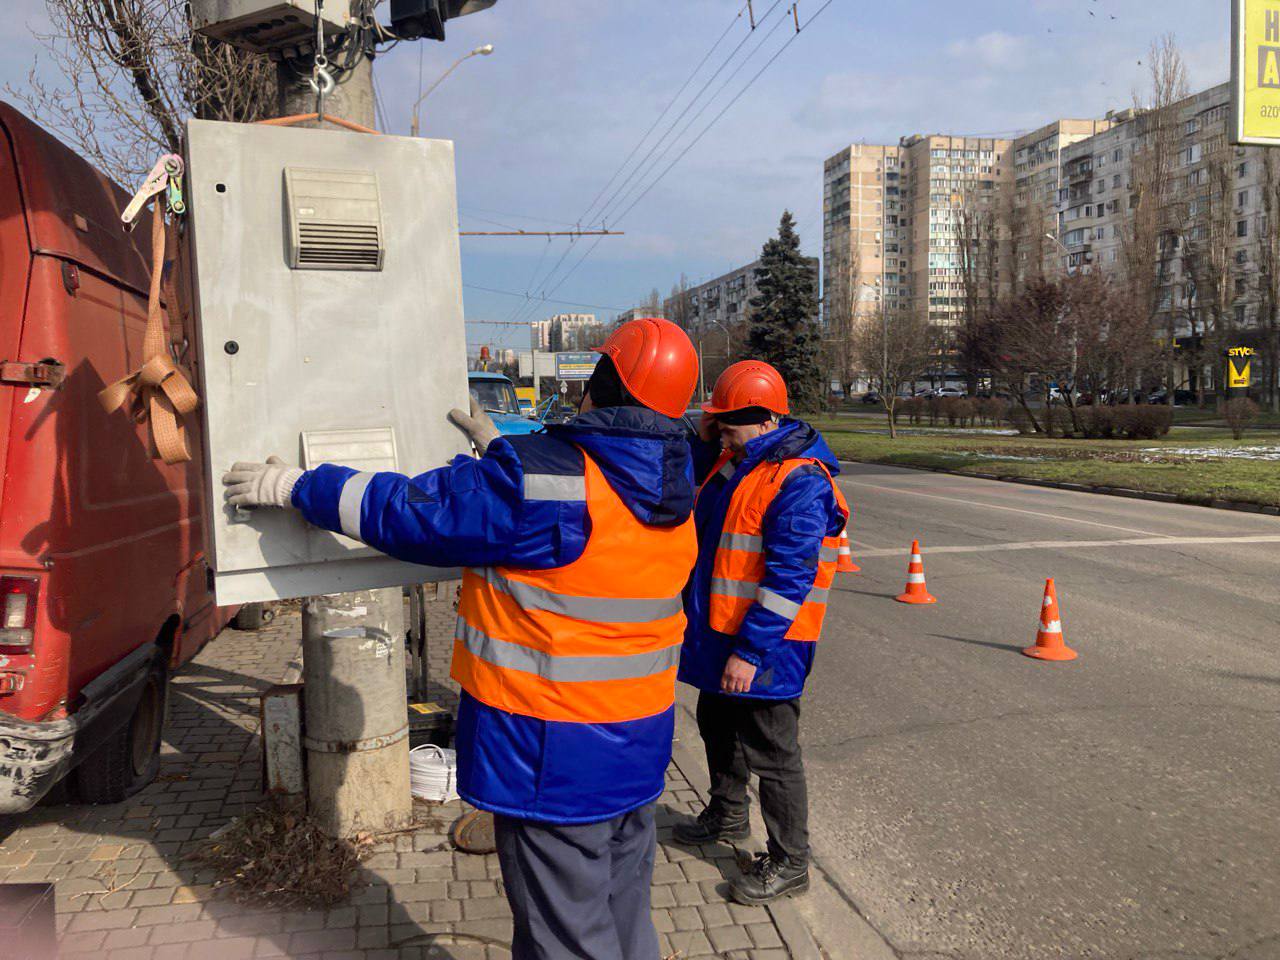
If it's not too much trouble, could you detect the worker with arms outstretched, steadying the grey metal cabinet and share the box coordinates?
[224,319,698,960]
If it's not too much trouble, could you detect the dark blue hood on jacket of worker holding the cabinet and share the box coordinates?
[547,407,696,526]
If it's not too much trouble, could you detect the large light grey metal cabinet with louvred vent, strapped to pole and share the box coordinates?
[187,120,470,605]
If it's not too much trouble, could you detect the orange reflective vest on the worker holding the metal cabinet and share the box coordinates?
[452,453,698,723]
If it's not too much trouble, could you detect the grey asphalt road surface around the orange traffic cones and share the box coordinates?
[797,465,1280,960]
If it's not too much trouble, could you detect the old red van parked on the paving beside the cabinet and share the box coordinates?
[0,104,254,813]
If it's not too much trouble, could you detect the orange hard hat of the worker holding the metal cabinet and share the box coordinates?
[595,316,698,417]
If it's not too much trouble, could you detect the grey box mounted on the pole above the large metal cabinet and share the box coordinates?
[191,0,351,54]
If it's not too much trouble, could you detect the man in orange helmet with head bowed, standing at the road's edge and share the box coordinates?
[675,360,849,904]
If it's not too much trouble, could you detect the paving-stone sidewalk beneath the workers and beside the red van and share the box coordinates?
[0,603,799,960]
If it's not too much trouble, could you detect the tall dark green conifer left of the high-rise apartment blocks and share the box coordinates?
[746,210,824,410]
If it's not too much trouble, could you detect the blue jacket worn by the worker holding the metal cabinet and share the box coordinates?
[293,407,694,823]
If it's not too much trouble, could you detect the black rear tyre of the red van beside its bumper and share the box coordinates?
[72,660,169,804]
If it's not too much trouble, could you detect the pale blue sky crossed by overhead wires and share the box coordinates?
[0,0,1229,344]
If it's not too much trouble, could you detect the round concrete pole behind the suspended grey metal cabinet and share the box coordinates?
[278,39,409,837]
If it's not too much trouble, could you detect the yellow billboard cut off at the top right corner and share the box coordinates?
[1231,0,1280,147]
